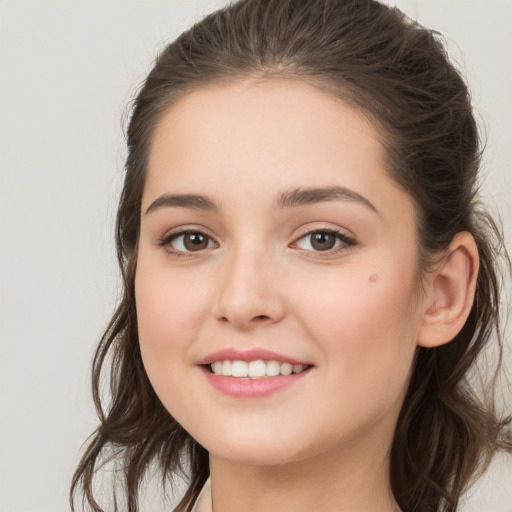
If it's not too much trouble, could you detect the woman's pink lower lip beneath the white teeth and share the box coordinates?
[202,367,311,398]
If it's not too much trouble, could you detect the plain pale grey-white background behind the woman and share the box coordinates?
[0,0,512,512]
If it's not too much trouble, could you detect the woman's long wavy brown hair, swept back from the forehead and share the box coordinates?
[70,0,510,512]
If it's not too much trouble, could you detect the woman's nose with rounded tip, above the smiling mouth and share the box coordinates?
[214,253,285,330]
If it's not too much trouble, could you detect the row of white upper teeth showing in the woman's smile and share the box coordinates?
[210,359,307,379]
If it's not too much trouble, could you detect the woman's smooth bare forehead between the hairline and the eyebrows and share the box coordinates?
[143,79,412,220]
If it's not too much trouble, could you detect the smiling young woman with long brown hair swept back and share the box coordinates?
[71,0,511,512]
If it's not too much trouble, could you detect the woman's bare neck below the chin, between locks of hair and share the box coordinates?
[210,440,399,512]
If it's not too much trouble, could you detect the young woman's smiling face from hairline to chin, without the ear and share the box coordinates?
[136,80,421,464]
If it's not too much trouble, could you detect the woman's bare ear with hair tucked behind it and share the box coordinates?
[417,231,479,348]
